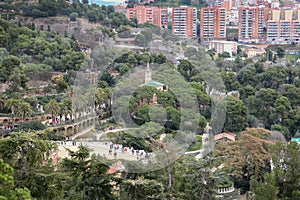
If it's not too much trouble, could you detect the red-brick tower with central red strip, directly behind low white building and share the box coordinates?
[200,6,226,41]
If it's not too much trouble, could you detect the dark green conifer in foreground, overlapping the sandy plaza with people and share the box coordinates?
[61,146,117,200]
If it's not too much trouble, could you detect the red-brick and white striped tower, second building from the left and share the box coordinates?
[172,6,197,37]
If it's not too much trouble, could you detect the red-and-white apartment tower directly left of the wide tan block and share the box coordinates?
[238,6,269,43]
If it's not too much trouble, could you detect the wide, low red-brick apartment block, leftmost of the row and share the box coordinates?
[126,6,168,28]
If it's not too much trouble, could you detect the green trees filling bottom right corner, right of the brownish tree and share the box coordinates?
[250,142,300,200]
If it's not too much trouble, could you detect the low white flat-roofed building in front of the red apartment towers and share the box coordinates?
[208,40,237,56]
